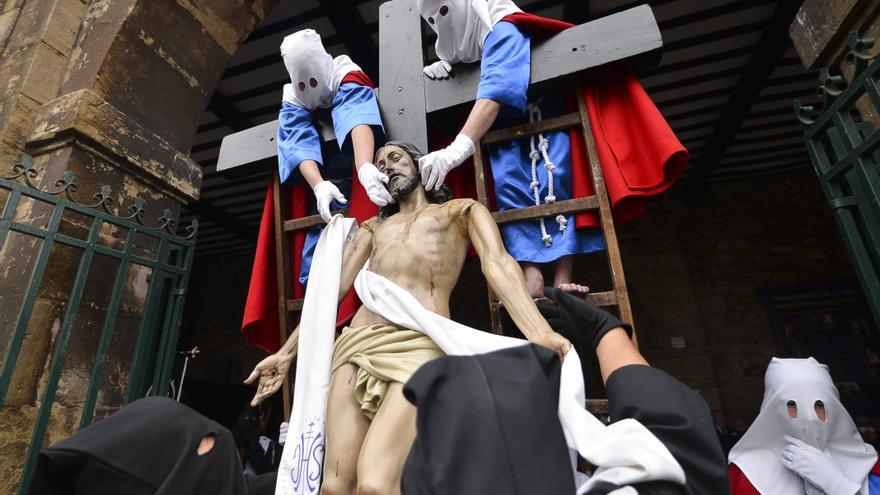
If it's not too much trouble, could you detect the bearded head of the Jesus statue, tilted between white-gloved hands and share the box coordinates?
[375,141,452,218]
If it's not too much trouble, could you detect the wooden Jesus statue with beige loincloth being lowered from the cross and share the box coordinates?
[246,142,571,494]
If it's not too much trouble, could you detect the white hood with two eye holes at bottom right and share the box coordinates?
[727,358,877,495]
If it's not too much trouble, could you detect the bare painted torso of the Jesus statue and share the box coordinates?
[351,199,473,327]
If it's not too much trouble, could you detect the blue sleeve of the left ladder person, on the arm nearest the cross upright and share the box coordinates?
[330,82,384,150]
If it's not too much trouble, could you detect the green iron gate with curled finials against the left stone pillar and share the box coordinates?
[0,157,198,493]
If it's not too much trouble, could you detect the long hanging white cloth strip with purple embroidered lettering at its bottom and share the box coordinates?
[275,215,357,495]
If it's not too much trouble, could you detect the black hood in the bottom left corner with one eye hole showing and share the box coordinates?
[29,397,274,495]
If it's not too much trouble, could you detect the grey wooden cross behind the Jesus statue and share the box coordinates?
[217,0,663,175]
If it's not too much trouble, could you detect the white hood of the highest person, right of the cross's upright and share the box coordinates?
[416,0,522,64]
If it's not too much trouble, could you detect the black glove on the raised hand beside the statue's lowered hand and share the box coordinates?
[536,287,632,349]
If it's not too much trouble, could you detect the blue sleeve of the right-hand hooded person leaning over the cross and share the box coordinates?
[477,21,532,113]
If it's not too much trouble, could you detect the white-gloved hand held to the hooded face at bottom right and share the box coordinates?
[781,435,862,495]
